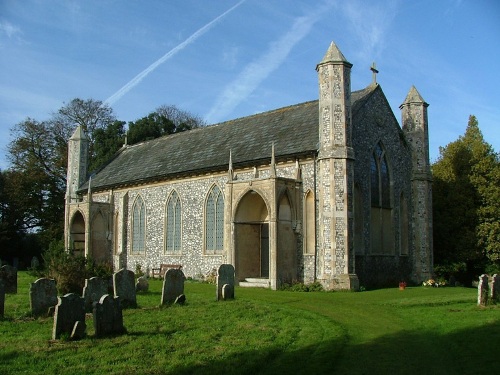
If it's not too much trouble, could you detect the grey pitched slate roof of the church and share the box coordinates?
[80,86,374,191]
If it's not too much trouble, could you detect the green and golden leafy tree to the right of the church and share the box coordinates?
[432,116,500,281]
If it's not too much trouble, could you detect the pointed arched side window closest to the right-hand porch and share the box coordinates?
[205,185,224,254]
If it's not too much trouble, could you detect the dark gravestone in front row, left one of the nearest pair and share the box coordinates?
[52,293,85,340]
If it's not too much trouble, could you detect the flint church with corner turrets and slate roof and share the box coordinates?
[65,42,433,290]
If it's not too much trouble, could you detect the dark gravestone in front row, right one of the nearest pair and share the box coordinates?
[93,294,125,336]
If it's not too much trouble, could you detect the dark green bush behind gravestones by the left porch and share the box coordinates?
[41,241,113,294]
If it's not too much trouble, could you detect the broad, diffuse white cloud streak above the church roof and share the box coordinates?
[205,2,332,124]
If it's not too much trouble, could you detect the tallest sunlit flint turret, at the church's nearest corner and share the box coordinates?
[316,42,359,289]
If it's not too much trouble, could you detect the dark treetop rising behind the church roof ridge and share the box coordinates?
[127,105,205,144]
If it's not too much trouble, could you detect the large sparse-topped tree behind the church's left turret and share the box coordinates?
[8,99,117,251]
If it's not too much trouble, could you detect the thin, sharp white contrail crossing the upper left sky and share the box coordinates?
[104,0,246,106]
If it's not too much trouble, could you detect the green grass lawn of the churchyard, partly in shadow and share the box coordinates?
[0,272,500,375]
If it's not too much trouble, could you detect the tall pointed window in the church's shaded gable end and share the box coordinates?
[370,142,394,254]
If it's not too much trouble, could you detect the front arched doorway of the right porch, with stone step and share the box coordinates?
[234,190,269,281]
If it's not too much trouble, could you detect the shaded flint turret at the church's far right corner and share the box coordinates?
[399,86,433,283]
